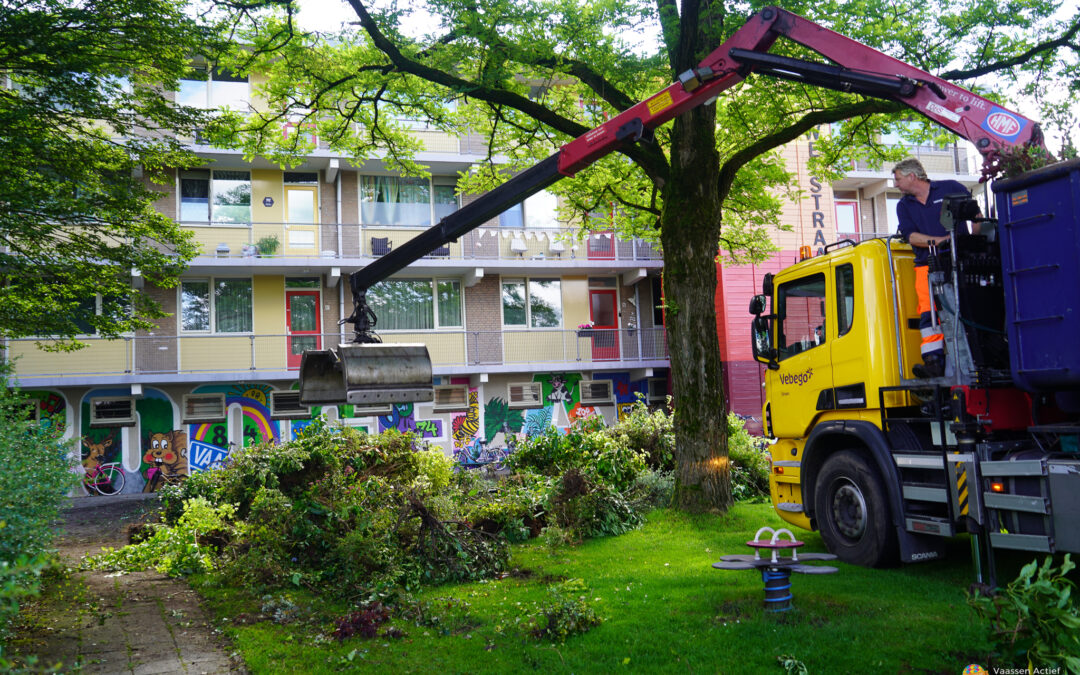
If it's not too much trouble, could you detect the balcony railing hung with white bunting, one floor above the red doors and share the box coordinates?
[181,222,663,264]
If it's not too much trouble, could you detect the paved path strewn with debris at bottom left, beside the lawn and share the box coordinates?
[16,495,246,675]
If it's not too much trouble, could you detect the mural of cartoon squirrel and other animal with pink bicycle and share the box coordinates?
[80,388,179,492]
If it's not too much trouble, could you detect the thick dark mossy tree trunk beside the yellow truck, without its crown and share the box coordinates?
[661,106,732,512]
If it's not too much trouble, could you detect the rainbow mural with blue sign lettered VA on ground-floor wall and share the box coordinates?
[188,383,281,471]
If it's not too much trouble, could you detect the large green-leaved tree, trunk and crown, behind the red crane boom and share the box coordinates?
[214,0,1078,510]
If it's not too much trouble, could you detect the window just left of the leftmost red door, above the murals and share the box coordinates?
[180,279,253,333]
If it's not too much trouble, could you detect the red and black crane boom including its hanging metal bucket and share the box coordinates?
[300,6,1041,405]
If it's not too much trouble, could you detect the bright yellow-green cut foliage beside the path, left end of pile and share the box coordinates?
[86,497,235,577]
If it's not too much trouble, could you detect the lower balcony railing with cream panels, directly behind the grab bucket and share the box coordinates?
[6,327,669,384]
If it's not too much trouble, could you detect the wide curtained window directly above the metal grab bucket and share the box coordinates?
[367,279,462,330]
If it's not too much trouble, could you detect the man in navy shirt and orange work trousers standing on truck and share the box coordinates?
[892,158,977,378]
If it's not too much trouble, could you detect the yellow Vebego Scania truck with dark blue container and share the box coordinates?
[751,160,1080,576]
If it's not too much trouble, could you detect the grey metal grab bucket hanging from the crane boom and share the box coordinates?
[300,343,435,405]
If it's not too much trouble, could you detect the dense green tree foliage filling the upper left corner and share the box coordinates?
[0,0,220,347]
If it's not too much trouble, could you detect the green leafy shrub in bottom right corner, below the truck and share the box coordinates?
[968,554,1080,673]
